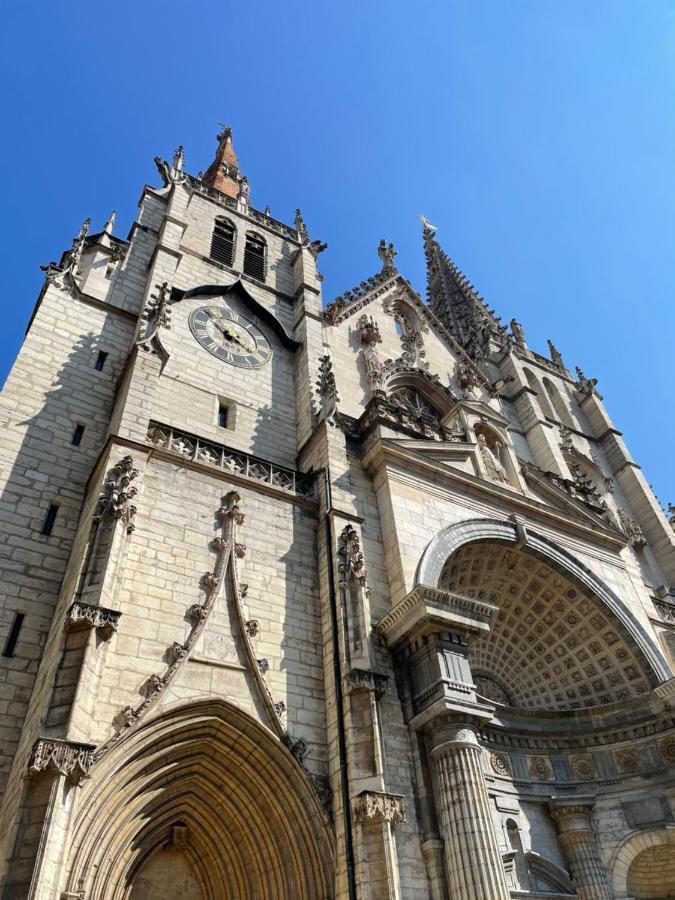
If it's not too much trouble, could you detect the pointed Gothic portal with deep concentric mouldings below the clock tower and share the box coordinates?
[68,700,334,900]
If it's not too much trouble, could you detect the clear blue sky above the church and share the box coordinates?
[0,0,675,502]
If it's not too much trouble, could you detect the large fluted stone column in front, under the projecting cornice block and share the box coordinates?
[429,715,509,900]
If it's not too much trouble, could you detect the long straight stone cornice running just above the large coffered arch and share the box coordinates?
[363,438,625,553]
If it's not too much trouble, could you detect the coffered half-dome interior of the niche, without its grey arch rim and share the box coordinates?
[439,541,653,710]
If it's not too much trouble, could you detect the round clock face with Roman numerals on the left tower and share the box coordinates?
[189,304,272,369]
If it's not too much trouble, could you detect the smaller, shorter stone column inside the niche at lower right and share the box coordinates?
[550,797,614,900]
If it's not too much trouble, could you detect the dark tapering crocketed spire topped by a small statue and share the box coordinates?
[420,216,505,359]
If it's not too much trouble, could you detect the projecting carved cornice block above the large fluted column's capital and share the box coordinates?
[377,584,497,647]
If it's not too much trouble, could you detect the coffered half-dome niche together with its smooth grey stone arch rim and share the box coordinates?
[416,519,670,710]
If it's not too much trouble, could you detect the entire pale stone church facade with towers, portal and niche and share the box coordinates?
[0,128,675,900]
